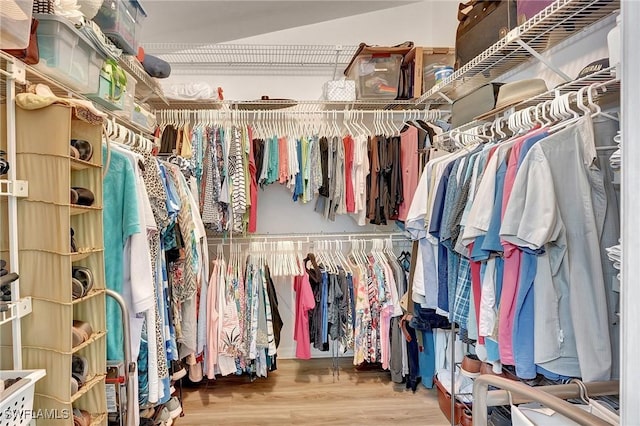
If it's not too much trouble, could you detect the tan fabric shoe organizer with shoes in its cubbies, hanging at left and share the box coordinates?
[10,105,107,426]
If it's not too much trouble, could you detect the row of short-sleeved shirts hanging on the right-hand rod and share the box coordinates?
[407,111,615,380]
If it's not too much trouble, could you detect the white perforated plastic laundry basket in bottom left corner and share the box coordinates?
[0,370,47,426]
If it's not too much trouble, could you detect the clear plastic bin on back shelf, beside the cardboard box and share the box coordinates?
[349,54,403,99]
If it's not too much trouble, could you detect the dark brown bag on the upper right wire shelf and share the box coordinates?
[455,0,518,69]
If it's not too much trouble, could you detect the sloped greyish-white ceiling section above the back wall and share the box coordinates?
[140,0,416,44]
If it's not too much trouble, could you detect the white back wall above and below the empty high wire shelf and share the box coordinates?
[166,0,458,100]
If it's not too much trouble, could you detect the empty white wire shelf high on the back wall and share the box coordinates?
[144,43,358,75]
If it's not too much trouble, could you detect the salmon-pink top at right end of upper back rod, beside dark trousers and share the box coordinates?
[398,126,420,221]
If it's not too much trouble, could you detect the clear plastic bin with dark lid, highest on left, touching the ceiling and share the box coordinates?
[93,0,147,55]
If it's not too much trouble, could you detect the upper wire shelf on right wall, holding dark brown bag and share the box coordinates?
[417,0,620,104]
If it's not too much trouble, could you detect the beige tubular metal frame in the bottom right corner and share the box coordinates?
[472,375,620,426]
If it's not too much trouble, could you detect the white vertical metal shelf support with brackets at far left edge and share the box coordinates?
[0,51,31,370]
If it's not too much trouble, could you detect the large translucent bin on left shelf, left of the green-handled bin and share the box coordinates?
[35,14,105,93]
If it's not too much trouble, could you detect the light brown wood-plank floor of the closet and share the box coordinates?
[175,358,448,426]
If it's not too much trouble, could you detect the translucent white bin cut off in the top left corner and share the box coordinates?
[0,0,33,49]
